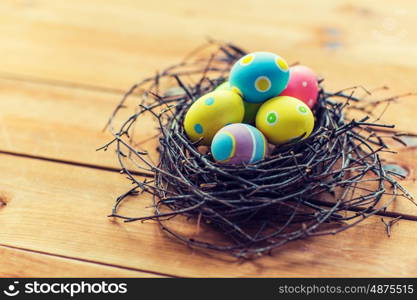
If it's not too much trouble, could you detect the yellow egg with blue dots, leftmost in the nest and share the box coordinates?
[184,91,244,145]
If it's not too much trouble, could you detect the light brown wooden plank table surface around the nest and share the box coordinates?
[0,0,417,277]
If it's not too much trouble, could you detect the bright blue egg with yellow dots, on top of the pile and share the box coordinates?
[229,52,290,103]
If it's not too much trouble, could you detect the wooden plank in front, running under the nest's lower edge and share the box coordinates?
[0,155,417,277]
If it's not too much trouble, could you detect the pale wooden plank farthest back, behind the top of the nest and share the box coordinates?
[0,0,417,95]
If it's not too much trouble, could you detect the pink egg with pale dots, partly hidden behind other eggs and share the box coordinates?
[280,66,319,108]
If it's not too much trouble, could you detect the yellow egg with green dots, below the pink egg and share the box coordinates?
[256,96,314,145]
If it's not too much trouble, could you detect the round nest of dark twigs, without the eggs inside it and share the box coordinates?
[101,42,413,258]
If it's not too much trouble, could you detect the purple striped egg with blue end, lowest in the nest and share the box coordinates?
[211,123,268,165]
